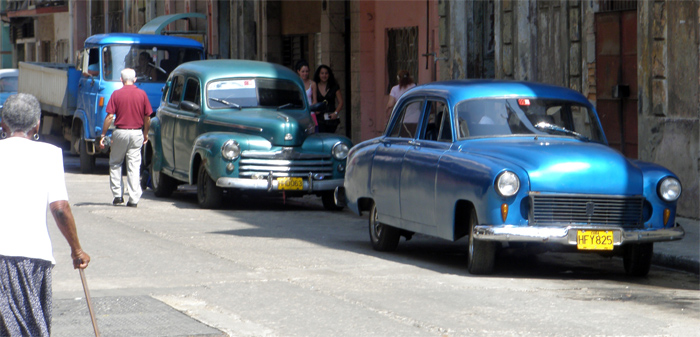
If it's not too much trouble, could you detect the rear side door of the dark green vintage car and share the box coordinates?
[158,75,185,172]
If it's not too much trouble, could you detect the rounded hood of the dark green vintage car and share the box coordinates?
[206,108,314,146]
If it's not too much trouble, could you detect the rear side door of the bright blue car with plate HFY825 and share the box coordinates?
[371,98,424,225]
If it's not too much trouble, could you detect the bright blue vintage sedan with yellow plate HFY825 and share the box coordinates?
[344,80,684,276]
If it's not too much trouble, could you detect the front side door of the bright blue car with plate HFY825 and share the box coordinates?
[400,98,452,234]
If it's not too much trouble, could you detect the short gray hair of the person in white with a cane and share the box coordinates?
[2,93,41,133]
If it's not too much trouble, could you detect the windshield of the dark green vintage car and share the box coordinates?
[207,78,304,109]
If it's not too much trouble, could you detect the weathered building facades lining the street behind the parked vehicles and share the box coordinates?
[0,0,700,218]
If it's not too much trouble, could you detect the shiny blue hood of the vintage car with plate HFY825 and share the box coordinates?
[461,137,644,195]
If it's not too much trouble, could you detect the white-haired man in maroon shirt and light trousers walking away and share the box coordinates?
[100,68,153,207]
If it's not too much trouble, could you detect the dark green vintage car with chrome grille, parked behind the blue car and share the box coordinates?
[150,60,352,210]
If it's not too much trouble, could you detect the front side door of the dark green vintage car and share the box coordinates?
[173,77,202,177]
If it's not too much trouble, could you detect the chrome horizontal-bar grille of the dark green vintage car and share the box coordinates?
[238,148,333,178]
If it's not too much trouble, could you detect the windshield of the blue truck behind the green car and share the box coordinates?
[102,45,202,83]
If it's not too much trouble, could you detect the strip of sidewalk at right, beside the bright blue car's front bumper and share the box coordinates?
[652,218,700,274]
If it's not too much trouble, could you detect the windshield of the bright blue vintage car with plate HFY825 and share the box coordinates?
[455,98,604,143]
